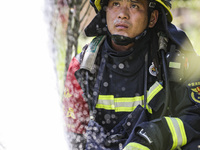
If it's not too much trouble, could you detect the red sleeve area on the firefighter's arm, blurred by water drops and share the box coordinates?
[63,57,89,147]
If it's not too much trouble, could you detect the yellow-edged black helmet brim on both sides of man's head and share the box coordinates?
[90,0,173,22]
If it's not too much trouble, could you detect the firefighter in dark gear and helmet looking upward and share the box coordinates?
[63,0,200,150]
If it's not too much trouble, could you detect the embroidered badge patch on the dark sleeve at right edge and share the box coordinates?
[188,82,200,103]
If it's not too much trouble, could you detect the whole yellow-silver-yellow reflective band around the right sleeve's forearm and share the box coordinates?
[165,117,187,150]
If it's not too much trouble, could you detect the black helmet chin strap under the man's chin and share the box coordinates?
[107,29,147,46]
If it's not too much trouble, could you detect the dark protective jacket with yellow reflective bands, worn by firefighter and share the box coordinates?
[63,22,200,150]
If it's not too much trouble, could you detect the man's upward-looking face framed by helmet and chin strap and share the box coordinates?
[106,0,148,38]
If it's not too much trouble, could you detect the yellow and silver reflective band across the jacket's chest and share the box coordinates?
[96,81,163,113]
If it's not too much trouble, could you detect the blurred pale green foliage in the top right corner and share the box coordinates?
[172,0,200,54]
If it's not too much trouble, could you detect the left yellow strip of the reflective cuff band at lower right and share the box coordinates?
[165,117,178,150]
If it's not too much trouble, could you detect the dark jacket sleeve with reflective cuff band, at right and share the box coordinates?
[129,53,200,150]
